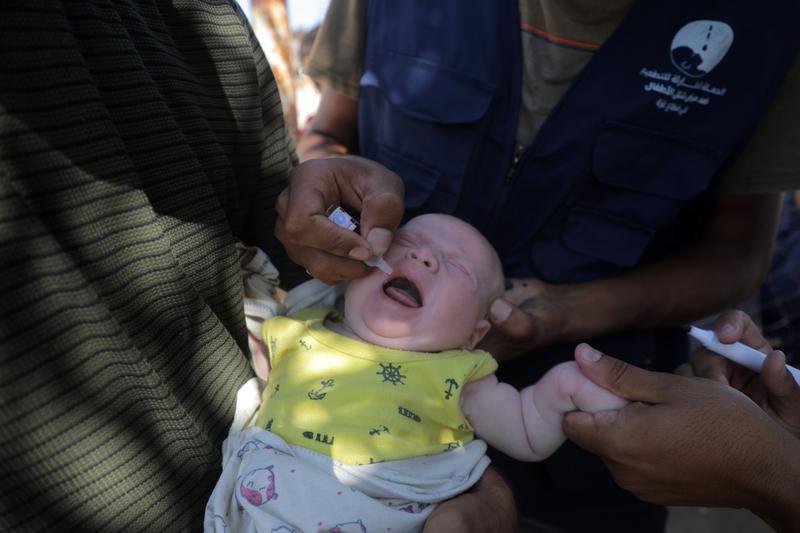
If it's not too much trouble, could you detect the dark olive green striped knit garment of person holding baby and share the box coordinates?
[0,0,304,531]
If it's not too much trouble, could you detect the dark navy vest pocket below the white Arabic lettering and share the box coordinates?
[562,122,720,268]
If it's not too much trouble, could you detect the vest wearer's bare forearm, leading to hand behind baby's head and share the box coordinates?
[553,194,780,341]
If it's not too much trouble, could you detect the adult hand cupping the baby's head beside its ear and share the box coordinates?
[478,278,567,361]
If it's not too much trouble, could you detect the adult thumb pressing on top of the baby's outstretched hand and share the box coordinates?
[575,343,676,403]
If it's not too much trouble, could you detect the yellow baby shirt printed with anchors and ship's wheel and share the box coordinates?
[256,309,497,464]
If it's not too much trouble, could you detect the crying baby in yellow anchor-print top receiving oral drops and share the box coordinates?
[206,215,626,533]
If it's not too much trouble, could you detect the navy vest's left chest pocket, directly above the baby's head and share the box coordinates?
[359,52,492,212]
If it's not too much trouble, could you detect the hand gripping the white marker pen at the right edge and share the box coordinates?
[692,311,800,437]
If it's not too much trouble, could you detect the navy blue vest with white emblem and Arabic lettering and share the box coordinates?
[359,0,800,370]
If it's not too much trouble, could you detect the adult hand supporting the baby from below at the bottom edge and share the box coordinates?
[423,467,517,533]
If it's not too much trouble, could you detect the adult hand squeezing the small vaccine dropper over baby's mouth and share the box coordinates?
[275,156,404,283]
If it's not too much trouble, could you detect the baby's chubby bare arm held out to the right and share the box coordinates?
[461,362,628,461]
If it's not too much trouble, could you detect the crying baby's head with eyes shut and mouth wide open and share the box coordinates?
[345,215,503,352]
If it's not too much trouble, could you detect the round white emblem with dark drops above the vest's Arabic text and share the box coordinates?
[670,20,733,78]
